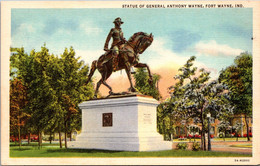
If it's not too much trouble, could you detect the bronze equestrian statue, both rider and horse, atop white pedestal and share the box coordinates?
[87,18,153,97]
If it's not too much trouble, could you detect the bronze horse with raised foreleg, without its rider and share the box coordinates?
[86,32,153,98]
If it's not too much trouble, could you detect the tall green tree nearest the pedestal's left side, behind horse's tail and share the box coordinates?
[58,47,94,148]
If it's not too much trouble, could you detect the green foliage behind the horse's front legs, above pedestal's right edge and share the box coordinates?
[134,68,161,100]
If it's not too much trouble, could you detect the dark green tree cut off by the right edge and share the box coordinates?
[219,52,253,141]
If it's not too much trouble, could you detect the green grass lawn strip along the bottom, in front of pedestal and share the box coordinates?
[10,144,252,157]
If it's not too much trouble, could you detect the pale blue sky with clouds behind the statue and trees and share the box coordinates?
[11,8,252,97]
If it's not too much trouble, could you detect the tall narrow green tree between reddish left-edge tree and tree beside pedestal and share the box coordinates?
[29,46,59,147]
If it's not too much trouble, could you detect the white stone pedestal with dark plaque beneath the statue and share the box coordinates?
[68,95,172,151]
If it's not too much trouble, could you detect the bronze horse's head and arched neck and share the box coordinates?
[129,32,153,54]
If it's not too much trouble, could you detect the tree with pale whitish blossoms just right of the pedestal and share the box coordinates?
[167,56,232,150]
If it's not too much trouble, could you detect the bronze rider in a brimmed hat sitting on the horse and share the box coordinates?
[103,17,126,71]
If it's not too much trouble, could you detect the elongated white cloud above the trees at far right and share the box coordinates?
[195,40,243,56]
